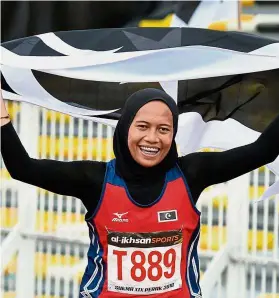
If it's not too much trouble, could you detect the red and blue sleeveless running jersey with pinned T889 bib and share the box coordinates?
[79,160,201,298]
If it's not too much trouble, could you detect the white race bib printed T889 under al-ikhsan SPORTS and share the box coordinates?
[107,231,182,295]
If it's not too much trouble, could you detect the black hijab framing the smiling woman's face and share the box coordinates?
[113,88,178,186]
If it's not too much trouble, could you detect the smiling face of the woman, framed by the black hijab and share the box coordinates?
[128,101,173,167]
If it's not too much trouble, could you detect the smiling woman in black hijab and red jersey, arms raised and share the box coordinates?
[1,89,279,298]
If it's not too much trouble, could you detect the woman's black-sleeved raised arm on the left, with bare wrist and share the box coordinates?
[0,87,105,201]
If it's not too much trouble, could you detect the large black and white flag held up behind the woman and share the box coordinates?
[1,27,279,199]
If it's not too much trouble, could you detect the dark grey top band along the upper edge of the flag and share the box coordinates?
[2,27,278,56]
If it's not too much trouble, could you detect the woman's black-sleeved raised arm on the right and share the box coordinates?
[179,115,279,201]
